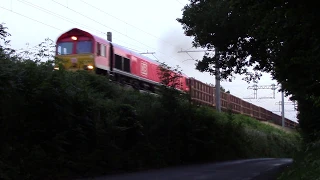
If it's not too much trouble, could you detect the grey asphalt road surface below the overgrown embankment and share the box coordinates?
[79,158,292,180]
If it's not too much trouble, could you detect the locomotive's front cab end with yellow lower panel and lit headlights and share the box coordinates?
[55,28,95,71]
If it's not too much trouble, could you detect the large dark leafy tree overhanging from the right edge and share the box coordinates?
[177,0,320,141]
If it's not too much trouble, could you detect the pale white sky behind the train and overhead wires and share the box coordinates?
[0,0,297,121]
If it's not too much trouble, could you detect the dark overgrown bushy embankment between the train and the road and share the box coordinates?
[0,24,299,180]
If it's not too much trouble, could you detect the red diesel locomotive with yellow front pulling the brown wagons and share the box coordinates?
[56,28,188,92]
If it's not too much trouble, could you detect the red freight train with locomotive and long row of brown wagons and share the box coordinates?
[55,28,298,128]
